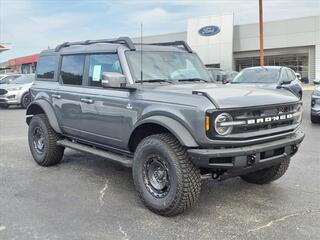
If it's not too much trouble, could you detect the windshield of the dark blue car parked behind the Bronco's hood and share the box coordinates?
[232,68,280,83]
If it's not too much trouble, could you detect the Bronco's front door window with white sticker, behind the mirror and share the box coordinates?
[89,53,122,87]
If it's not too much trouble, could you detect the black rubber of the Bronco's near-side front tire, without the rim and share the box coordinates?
[132,133,201,216]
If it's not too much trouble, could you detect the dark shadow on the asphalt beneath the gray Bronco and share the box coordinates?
[59,150,283,217]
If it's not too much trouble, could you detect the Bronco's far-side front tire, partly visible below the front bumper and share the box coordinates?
[241,159,290,184]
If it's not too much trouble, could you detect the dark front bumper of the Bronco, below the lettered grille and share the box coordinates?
[188,131,305,173]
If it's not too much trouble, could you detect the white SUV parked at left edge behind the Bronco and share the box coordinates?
[0,74,35,108]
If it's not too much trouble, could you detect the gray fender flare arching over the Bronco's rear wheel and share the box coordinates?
[26,99,62,133]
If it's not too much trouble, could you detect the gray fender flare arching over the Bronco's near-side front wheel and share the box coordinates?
[135,116,199,148]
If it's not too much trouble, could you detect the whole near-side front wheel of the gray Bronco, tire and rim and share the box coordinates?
[132,134,201,216]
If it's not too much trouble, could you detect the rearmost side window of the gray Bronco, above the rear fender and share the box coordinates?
[37,56,58,79]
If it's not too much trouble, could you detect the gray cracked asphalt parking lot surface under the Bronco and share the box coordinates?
[0,91,320,240]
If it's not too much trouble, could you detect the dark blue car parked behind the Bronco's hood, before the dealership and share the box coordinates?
[231,66,302,99]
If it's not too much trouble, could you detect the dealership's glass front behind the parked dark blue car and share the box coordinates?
[235,53,309,79]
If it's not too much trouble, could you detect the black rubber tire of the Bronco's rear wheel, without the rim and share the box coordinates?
[28,114,64,167]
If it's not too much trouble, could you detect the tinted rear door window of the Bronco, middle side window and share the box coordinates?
[60,55,85,85]
